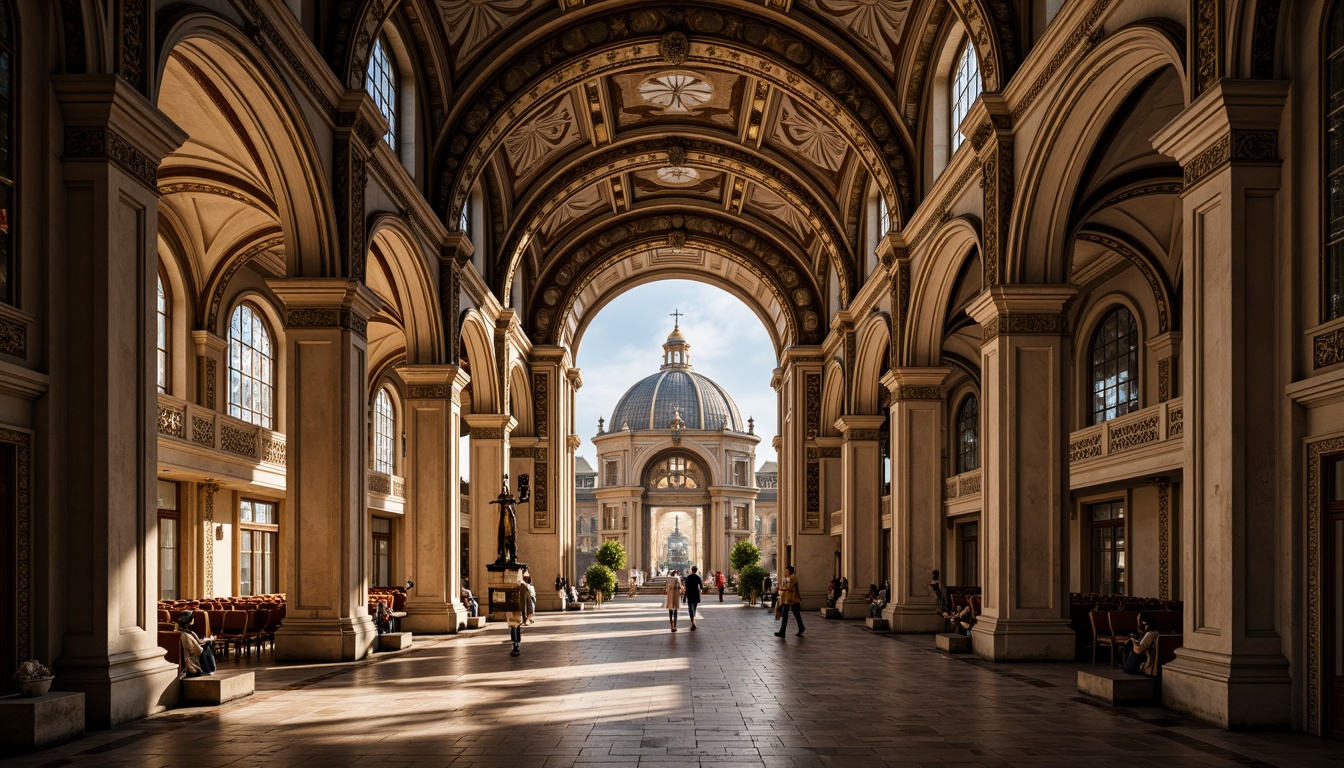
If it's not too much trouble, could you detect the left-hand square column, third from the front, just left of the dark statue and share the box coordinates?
[396,366,470,635]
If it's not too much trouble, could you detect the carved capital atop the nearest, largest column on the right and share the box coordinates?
[1152,78,1289,191]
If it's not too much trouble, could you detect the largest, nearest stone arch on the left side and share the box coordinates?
[153,11,341,277]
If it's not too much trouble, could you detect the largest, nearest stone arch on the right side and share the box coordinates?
[1003,22,1188,282]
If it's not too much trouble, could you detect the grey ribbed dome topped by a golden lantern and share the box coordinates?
[610,322,743,432]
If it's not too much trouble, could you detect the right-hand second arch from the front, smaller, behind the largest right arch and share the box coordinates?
[908,217,981,366]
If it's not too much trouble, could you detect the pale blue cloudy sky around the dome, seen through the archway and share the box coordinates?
[575,280,778,468]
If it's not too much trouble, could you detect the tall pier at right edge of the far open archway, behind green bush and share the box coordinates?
[770,346,835,611]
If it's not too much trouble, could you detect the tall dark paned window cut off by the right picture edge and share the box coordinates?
[1321,3,1344,320]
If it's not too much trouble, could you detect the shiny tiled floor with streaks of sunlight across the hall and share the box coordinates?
[5,597,1344,768]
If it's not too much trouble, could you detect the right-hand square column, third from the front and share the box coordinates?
[882,367,952,632]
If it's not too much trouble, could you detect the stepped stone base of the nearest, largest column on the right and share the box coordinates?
[1163,648,1293,729]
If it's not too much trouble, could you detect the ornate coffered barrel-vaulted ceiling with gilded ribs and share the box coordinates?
[336,0,1016,343]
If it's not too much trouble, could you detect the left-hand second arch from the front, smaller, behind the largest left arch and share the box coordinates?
[366,214,444,363]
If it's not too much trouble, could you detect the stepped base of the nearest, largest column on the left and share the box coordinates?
[55,646,177,729]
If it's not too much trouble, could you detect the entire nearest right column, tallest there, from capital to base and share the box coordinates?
[1153,78,1298,728]
